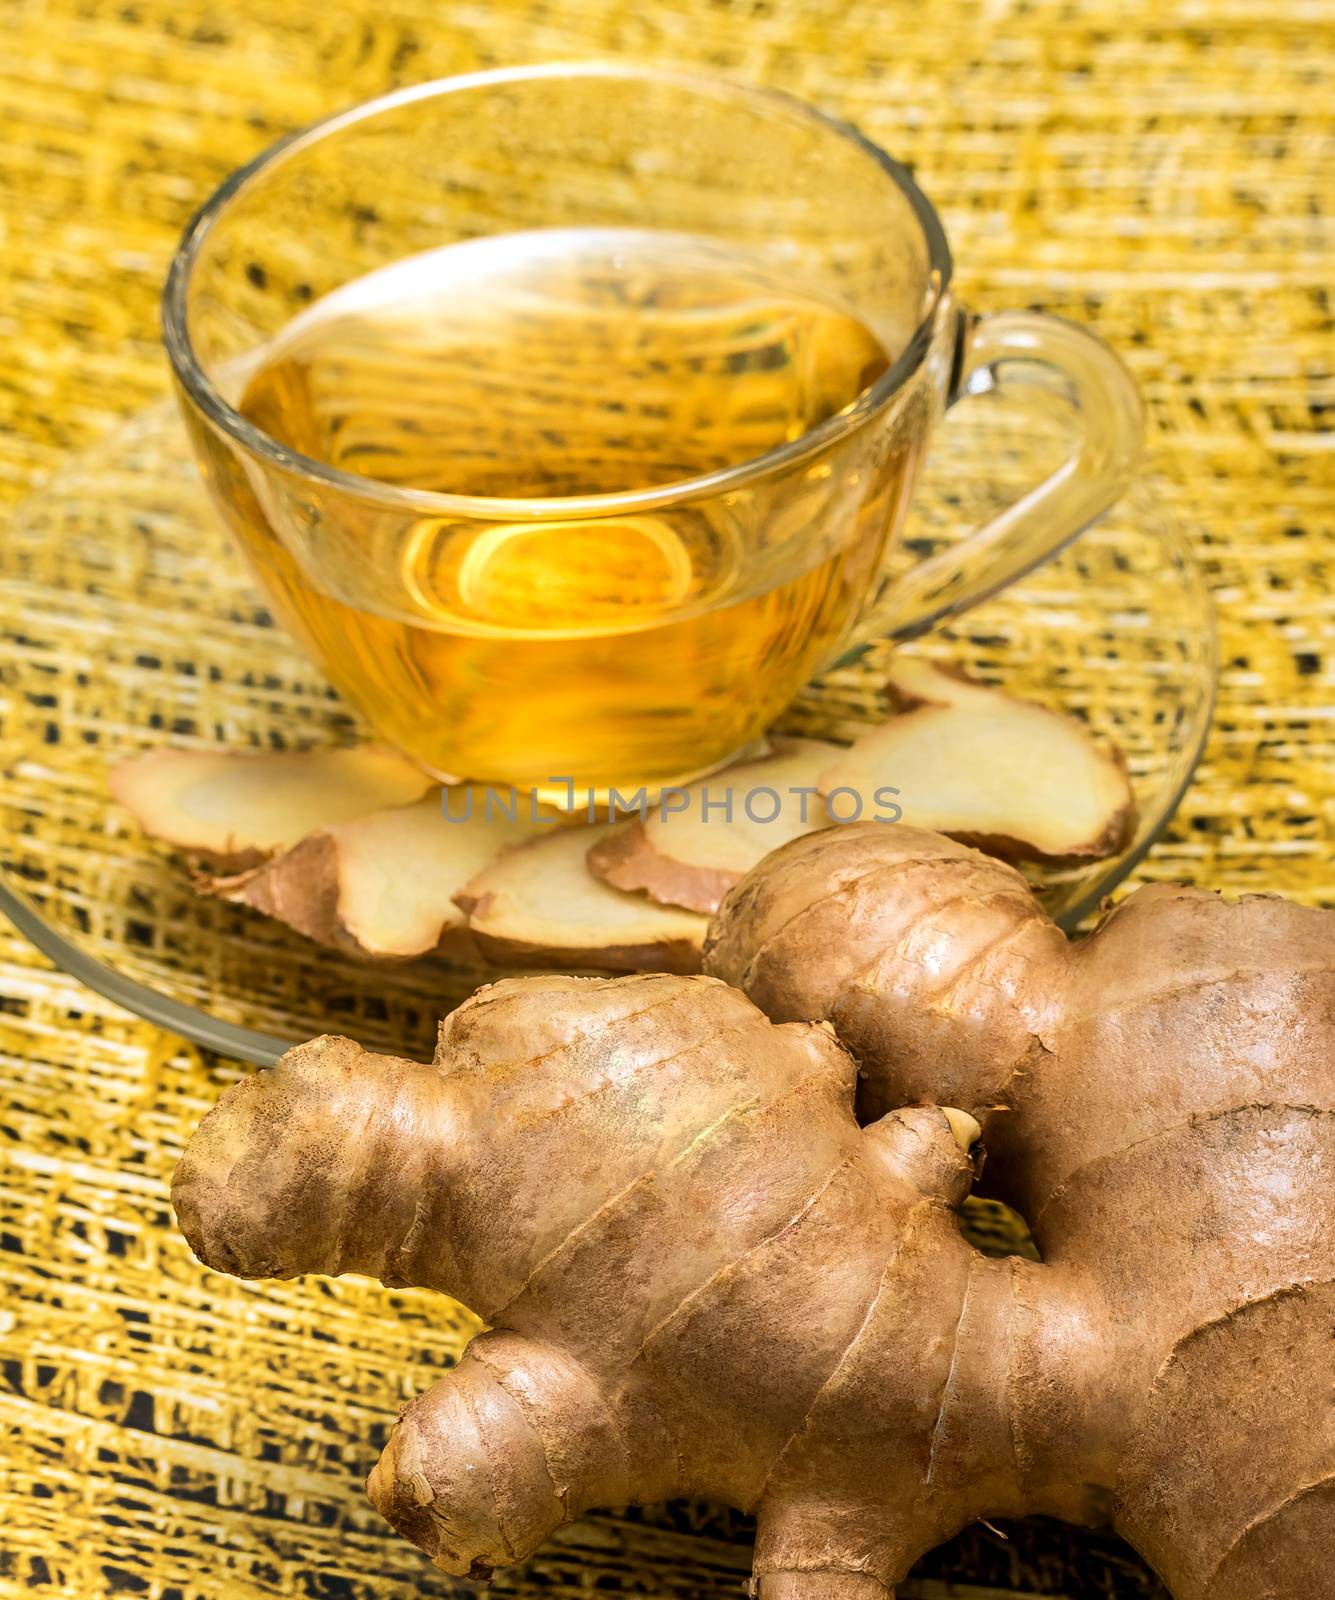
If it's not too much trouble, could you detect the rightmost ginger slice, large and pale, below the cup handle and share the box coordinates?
[820,656,1135,864]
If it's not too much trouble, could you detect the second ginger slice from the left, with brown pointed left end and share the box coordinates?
[208,787,554,958]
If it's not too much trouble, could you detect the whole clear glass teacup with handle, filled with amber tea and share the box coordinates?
[165,64,1141,794]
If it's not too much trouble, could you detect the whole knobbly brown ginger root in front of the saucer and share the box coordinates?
[173,824,1335,1600]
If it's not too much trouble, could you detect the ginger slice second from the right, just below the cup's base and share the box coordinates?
[587,739,840,912]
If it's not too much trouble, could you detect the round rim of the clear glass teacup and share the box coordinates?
[162,61,952,518]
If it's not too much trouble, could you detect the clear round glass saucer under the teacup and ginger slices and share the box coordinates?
[0,395,1217,1062]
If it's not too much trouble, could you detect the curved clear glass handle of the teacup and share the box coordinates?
[840,310,1145,646]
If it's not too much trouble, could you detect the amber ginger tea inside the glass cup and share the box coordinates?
[224,229,908,787]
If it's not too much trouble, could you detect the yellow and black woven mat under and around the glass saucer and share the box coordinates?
[0,0,1335,1600]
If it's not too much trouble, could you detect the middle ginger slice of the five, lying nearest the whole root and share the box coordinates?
[456,822,709,973]
